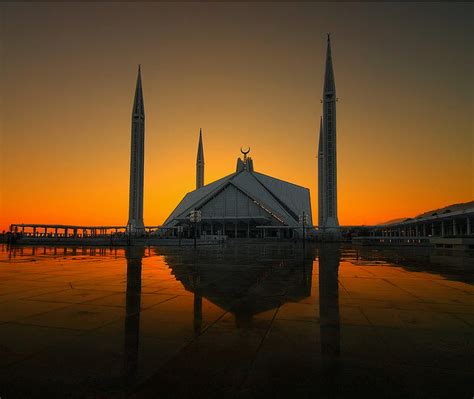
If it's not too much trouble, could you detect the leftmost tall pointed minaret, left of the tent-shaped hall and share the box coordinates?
[127,66,145,233]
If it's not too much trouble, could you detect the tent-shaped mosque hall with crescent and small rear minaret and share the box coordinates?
[163,142,312,238]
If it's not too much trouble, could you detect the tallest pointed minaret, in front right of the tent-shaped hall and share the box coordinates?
[320,34,339,232]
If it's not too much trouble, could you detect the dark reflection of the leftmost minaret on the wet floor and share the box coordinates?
[124,246,145,391]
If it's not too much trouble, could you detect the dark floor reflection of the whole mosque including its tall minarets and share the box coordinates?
[120,244,340,395]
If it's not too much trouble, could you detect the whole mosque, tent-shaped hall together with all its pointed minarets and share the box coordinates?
[127,35,339,239]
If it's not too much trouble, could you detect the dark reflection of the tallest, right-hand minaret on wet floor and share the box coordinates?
[319,244,341,397]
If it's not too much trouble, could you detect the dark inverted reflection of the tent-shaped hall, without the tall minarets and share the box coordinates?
[164,246,313,327]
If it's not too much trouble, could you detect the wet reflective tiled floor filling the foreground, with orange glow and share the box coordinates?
[0,243,474,398]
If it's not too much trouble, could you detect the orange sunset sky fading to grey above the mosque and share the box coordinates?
[0,2,474,231]
